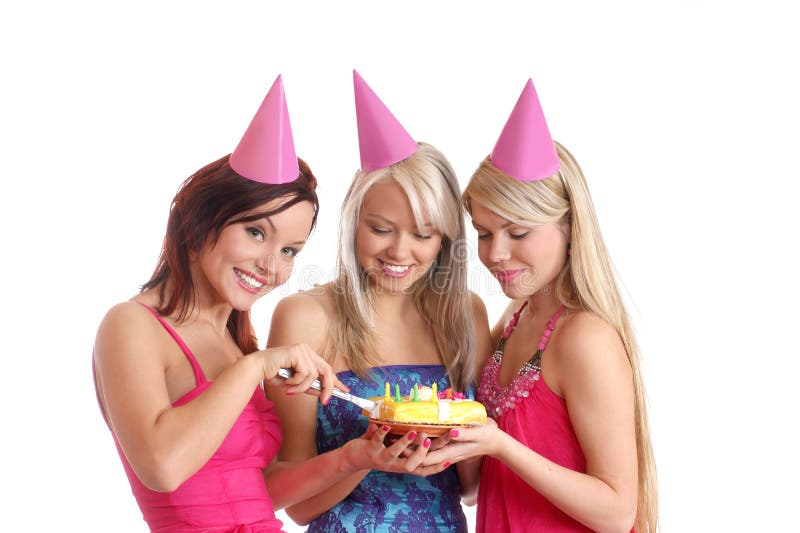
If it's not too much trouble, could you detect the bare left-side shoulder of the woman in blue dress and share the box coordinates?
[267,285,335,351]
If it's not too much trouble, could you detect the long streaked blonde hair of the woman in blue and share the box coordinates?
[329,143,476,390]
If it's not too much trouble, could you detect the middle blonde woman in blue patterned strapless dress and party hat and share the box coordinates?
[268,74,491,532]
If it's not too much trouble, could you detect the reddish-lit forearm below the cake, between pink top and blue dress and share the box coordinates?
[265,448,369,525]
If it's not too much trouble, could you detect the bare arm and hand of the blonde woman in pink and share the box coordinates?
[426,313,637,532]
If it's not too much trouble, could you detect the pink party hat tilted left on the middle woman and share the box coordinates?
[353,70,417,172]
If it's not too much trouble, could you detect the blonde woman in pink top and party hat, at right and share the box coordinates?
[426,81,658,533]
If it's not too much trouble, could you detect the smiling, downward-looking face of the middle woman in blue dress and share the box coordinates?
[356,182,442,294]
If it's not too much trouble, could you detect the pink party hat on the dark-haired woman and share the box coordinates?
[230,74,300,185]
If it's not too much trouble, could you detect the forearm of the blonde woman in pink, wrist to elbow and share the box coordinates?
[493,434,636,533]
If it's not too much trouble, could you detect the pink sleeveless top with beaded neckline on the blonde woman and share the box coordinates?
[476,306,591,533]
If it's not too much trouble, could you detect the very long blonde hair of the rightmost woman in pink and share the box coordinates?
[462,143,658,533]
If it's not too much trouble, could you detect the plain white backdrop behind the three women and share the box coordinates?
[0,0,800,532]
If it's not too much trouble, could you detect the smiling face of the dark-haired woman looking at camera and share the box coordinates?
[195,198,314,311]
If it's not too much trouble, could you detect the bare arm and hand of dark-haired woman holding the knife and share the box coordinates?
[94,302,334,492]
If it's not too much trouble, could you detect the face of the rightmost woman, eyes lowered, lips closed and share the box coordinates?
[471,200,569,298]
